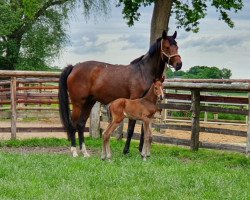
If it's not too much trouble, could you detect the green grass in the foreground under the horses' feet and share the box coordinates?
[0,138,250,200]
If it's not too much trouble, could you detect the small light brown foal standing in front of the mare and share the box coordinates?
[101,77,164,160]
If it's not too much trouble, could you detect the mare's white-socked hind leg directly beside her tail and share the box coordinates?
[70,105,81,157]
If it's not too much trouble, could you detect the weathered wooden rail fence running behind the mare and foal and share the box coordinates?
[0,70,250,154]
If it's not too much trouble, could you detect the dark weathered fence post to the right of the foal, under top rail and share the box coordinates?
[190,90,200,151]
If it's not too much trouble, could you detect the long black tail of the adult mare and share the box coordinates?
[58,65,73,139]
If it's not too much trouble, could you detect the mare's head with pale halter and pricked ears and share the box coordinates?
[160,31,182,71]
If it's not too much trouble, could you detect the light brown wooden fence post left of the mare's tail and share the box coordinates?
[10,77,17,139]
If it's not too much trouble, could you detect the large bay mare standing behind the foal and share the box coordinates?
[58,31,182,157]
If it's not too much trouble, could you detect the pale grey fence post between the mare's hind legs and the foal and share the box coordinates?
[89,102,101,138]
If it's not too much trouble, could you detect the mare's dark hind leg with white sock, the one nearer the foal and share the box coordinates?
[77,99,95,157]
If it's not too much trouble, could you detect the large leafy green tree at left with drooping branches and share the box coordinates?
[0,0,109,70]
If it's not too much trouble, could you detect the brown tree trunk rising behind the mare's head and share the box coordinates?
[150,0,173,45]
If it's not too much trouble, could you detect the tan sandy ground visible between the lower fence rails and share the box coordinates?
[0,121,247,145]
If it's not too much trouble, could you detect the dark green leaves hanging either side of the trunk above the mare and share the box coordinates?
[117,0,243,33]
